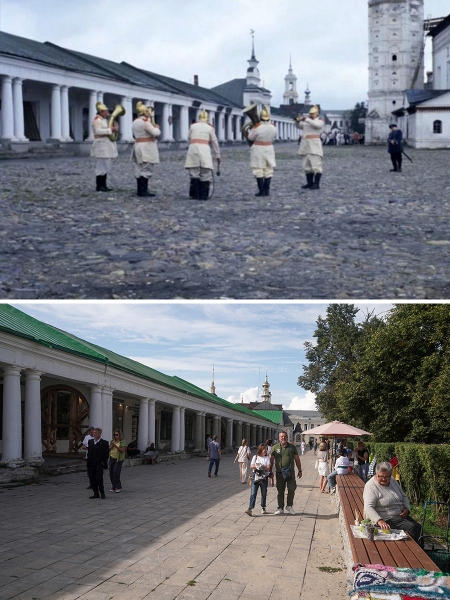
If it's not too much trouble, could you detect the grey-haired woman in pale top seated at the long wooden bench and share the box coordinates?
[363,462,421,542]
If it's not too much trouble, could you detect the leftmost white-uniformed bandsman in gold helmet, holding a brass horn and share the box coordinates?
[91,102,119,192]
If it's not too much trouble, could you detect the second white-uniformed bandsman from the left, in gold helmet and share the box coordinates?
[131,102,161,197]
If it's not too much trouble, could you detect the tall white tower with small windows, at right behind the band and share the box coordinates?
[366,0,425,143]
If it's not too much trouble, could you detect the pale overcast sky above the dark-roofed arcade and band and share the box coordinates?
[0,0,450,110]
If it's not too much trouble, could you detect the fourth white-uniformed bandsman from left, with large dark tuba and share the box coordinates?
[247,106,277,196]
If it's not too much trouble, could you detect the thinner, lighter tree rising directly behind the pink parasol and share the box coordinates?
[298,304,380,420]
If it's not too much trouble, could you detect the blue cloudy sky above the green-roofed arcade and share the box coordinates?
[11,301,392,410]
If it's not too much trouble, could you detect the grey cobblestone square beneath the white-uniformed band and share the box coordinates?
[0,142,450,299]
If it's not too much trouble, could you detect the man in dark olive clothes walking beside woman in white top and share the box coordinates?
[270,431,302,515]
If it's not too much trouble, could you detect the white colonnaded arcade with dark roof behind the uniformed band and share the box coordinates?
[0,32,292,153]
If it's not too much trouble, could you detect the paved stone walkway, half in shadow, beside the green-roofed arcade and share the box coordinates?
[0,452,346,600]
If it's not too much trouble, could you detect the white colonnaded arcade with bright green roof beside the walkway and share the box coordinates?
[0,304,280,467]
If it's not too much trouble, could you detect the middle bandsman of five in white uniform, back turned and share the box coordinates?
[184,110,220,200]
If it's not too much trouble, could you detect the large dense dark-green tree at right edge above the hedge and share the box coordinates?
[335,304,450,443]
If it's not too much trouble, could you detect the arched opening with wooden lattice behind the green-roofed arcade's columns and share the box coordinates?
[41,384,89,454]
